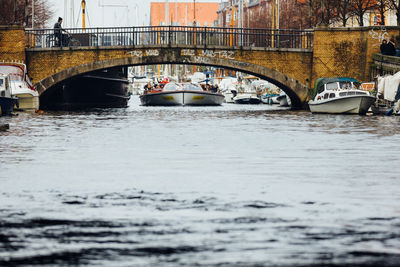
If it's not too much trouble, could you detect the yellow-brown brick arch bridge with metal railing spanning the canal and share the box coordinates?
[0,26,399,106]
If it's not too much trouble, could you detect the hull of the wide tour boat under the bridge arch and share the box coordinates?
[140,91,224,106]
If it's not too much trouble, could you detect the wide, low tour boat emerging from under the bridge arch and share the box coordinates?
[140,83,224,106]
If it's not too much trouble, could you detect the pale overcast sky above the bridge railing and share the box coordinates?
[48,0,221,28]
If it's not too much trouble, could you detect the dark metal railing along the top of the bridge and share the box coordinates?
[25,26,314,49]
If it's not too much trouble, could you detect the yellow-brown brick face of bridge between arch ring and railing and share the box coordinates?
[27,49,312,85]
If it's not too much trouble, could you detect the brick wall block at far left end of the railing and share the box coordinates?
[0,26,25,62]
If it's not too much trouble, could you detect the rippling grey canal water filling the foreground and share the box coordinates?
[0,97,400,266]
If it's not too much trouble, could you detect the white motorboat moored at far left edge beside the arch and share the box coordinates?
[0,62,39,111]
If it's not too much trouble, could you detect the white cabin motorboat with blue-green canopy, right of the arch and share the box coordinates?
[308,78,375,115]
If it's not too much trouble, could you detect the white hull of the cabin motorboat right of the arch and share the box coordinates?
[308,95,375,115]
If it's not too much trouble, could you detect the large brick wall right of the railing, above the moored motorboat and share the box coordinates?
[312,27,399,85]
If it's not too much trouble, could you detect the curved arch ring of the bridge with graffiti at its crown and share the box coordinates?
[35,53,308,107]
